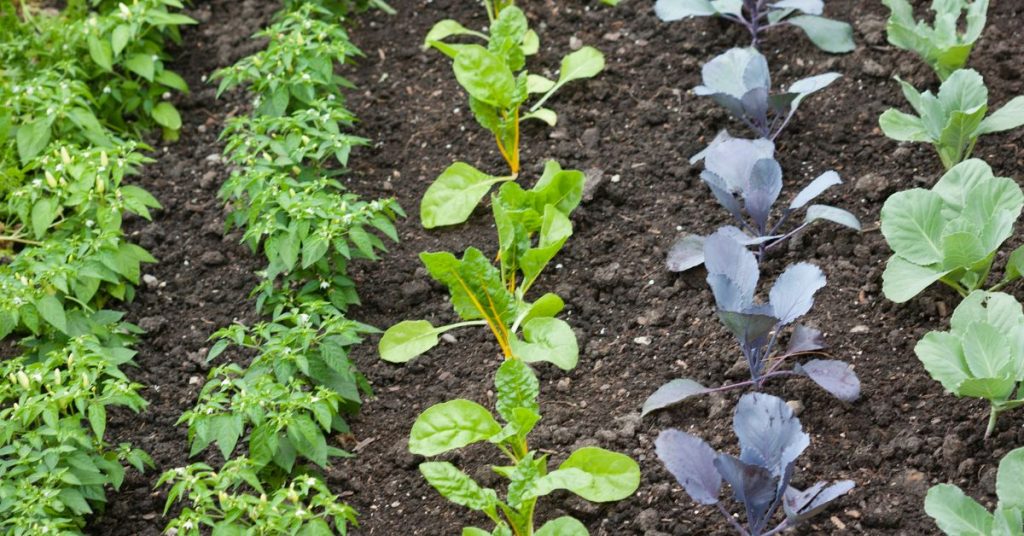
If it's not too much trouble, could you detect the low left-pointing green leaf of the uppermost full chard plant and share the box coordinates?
[420,162,512,229]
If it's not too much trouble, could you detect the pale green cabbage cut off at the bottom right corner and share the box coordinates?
[925,448,1024,536]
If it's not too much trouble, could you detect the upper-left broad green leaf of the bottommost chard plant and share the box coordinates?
[409,400,502,456]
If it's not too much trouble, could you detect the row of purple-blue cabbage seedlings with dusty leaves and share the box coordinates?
[641,0,872,536]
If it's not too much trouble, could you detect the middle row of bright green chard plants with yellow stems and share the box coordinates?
[379,0,640,536]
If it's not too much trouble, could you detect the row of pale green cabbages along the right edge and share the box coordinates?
[879,0,1024,535]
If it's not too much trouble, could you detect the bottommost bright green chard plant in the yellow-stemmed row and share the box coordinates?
[409,361,640,536]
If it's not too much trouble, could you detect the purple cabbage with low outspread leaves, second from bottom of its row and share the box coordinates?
[642,231,860,415]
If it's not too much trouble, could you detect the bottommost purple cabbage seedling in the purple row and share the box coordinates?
[654,393,854,536]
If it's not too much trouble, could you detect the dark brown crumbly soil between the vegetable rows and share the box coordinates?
[92,0,1024,536]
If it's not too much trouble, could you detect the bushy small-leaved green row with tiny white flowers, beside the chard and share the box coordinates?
[158,0,403,536]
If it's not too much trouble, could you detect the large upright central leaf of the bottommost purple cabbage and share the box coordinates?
[732,393,811,477]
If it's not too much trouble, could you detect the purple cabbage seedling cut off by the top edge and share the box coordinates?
[654,0,854,53]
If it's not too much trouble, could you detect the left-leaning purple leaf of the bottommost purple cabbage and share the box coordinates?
[654,428,722,504]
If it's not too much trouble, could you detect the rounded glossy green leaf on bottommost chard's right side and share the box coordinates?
[558,447,640,502]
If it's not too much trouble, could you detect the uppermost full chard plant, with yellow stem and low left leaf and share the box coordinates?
[420,6,604,229]
